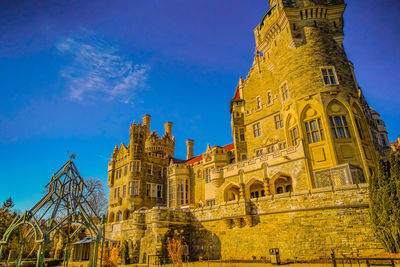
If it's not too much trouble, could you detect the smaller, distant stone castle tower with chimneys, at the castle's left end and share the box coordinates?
[108,115,175,222]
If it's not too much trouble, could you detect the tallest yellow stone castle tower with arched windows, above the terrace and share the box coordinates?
[231,0,377,188]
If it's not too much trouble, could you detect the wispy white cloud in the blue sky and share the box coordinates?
[56,32,149,104]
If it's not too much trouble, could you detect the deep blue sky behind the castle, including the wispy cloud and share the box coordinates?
[0,0,400,214]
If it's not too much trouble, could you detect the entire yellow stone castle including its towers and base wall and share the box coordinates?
[106,0,391,262]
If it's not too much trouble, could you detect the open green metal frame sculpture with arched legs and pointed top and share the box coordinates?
[0,159,104,267]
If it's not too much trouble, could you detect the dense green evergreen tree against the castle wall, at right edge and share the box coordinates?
[369,154,400,253]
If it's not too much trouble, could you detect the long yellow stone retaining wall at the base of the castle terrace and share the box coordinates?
[107,184,382,260]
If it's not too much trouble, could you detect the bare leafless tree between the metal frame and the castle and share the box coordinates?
[84,178,107,220]
